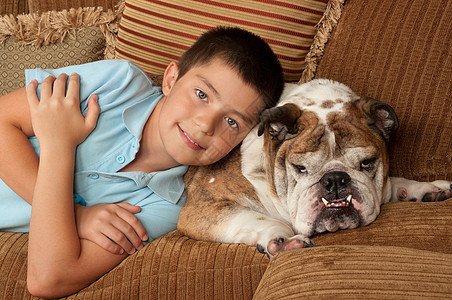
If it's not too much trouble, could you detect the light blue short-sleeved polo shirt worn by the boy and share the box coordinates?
[0,60,187,240]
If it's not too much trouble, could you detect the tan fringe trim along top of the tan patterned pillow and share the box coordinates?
[0,1,124,58]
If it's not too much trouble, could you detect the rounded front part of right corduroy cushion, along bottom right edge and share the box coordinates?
[253,245,452,300]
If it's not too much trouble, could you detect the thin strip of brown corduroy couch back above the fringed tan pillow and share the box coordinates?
[28,0,119,13]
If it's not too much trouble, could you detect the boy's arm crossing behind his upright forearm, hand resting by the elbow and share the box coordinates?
[0,79,146,254]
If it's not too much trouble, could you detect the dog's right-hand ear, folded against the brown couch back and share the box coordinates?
[362,98,399,143]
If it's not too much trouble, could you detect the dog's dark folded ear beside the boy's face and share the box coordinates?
[257,103,301,141]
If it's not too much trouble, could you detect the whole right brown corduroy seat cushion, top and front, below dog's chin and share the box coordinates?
[255,199,452,299]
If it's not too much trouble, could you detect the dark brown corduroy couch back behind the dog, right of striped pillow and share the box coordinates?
[310,0,452,181]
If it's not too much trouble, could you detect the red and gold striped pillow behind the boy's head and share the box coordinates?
[115,0,328,81]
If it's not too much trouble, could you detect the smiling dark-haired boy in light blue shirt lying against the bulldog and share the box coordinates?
[0,28,283,297]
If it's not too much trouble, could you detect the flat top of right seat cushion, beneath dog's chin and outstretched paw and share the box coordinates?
[313,199,452,253]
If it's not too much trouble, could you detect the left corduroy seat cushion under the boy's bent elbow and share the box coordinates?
[0,232,268,300]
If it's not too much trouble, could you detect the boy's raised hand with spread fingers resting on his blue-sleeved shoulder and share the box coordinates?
[27,73,99,147]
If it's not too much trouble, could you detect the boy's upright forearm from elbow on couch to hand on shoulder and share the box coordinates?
[27,75,129,298]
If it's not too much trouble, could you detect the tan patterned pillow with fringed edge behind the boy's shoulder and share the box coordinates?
[0,8,121,95]
